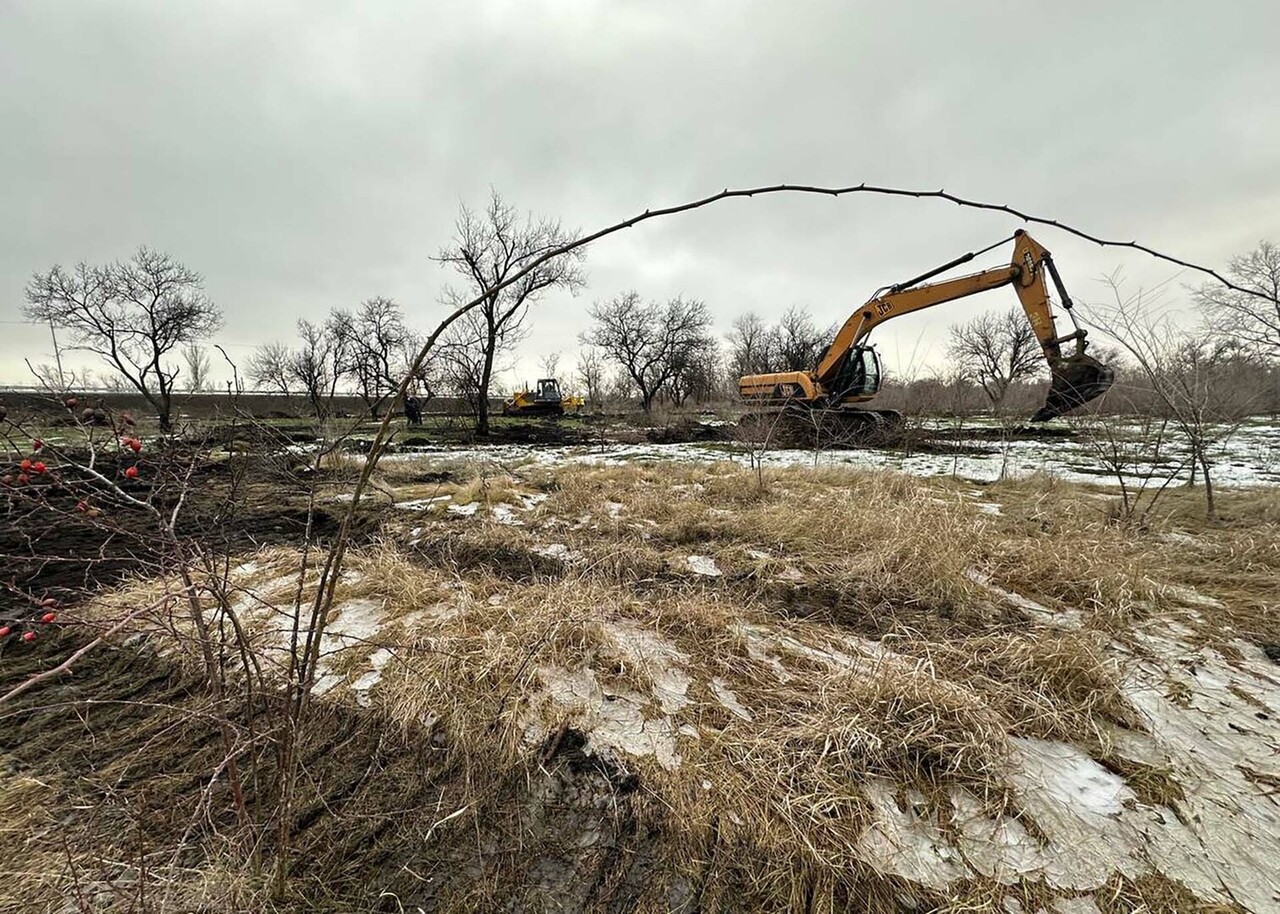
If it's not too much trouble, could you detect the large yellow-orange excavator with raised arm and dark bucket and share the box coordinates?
[739,229,1115,430]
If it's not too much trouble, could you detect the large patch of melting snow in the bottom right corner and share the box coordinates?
[859,621,1280,914]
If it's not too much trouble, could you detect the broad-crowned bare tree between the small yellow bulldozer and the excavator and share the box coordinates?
[581,292,713,412]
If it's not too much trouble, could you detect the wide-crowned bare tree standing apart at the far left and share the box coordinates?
[24,247,221,431]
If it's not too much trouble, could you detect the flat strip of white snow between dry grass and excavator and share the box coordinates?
[384,422,1280,486]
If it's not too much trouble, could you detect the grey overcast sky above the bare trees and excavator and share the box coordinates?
[0,0,1280,383]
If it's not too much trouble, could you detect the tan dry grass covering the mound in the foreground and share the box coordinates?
[20,461,1277,910]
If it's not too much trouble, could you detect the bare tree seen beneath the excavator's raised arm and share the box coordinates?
[947,307,1044,412]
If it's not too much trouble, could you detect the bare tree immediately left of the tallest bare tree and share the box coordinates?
[329,296,419,419]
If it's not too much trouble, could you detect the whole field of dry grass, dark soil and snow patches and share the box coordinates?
[0,407,1280,913]
